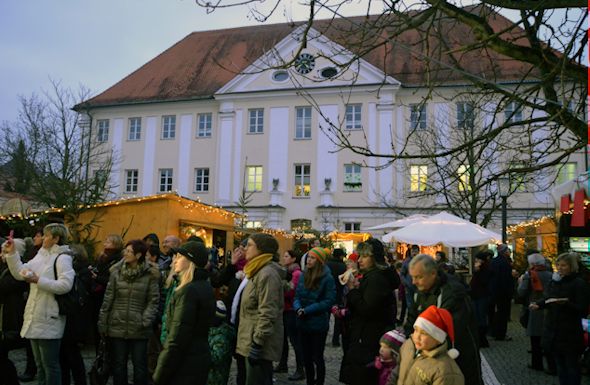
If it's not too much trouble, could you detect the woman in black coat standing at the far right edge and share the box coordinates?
[529,253,589,385]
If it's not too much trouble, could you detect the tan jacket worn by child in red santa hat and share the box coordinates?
[397,339,469,385]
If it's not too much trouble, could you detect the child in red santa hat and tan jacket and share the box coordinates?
[398,305,465,385]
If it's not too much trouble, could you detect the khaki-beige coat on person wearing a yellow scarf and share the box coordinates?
[236,262,285,361]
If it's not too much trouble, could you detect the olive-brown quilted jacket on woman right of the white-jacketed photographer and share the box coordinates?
[98,261,160,339]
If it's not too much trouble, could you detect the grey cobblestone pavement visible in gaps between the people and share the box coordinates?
[10,305,590,385]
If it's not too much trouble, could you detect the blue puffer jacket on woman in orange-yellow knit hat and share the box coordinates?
[293,266,336,332]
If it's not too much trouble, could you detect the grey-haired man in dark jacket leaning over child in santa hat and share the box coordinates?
[404,254,483,385]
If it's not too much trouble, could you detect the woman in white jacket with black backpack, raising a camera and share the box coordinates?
[2,223,75,385]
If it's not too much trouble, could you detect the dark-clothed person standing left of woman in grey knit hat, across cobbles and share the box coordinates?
[490,244,514,341]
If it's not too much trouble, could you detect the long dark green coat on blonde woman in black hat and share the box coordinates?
[154,269,215,385]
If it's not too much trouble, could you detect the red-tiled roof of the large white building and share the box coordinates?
[76,7,529,108]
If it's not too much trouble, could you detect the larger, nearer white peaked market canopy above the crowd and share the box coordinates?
[381,211,502,247]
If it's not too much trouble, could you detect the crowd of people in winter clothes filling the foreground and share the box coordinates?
[0,223,590,385]
